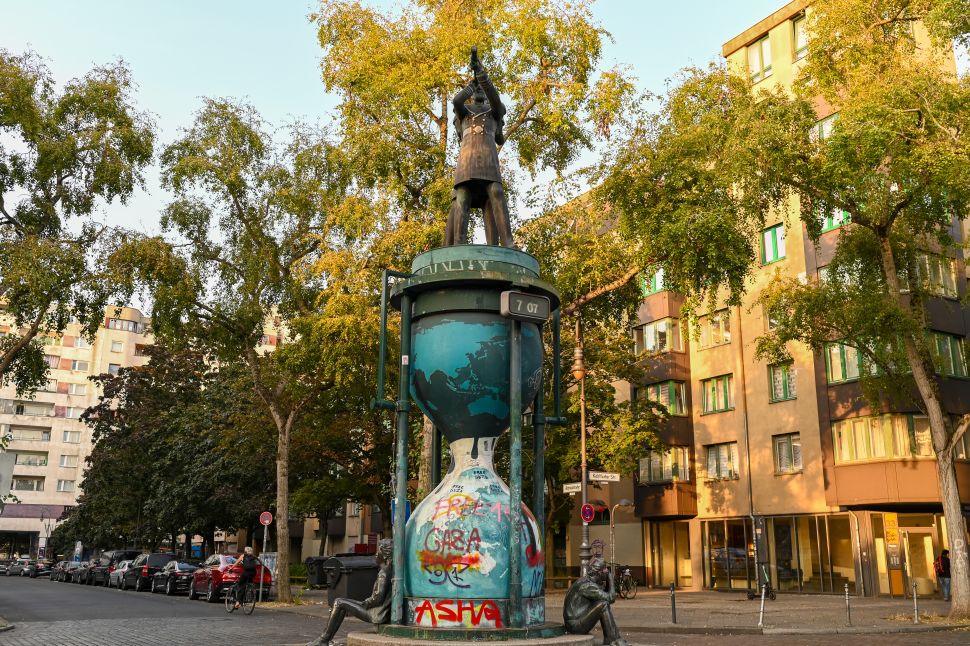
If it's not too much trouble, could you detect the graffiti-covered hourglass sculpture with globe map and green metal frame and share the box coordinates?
[370,245,562,640]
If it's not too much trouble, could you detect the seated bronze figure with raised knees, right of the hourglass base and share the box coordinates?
[562,558,627,646]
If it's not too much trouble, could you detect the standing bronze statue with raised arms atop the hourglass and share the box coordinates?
[445,47,515,247]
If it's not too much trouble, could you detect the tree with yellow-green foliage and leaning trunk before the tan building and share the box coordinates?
[602,0,970,618]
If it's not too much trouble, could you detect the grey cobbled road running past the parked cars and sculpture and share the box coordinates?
[0,577,970,646]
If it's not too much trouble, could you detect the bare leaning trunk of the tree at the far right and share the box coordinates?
[880,238,970,621]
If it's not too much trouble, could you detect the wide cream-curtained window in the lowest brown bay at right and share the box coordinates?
[832,415,933,464]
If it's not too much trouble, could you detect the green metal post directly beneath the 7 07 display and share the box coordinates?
[509,319,522,628]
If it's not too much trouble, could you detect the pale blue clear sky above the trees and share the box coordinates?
[0,0,944,232]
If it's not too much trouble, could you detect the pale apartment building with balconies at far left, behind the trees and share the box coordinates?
[0,307,152,557]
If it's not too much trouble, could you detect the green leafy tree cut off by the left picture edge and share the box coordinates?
[0,50,155,393]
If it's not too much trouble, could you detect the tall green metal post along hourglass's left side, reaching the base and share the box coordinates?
[391,293,411,624]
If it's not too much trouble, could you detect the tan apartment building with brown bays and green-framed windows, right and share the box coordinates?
[569,0,970,596]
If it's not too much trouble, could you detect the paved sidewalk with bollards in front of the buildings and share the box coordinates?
[278,588,970,635]
